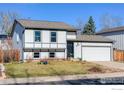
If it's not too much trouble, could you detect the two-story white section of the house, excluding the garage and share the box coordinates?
[12,20,76,59]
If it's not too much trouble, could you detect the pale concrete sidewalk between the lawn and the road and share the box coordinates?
[0,72,124,85]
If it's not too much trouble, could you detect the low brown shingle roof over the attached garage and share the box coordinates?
[68,35,113,43]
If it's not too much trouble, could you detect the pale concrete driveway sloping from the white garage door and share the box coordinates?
[91,61,124,70]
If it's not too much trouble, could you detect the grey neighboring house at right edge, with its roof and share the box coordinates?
[96,26,124,50]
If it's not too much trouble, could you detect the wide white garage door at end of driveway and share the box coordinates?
[82,46,111,61]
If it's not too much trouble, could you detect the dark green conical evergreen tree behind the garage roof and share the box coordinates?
[82,16,96,35]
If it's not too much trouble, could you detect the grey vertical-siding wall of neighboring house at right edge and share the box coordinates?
[100,31,124,50]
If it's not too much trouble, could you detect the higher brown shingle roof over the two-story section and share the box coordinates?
[16,19,76,31]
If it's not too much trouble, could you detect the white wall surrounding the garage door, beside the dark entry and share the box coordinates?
[74,42,113,60]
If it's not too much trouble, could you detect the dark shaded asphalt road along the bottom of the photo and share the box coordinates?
[7,77,124,85]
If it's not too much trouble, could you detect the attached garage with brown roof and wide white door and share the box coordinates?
[69,35,113,61]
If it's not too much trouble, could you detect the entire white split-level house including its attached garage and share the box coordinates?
[12,19,113,61]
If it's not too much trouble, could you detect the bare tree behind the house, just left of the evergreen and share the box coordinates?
[75,18,84,35]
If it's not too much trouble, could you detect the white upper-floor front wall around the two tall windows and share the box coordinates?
[24,30,67,49]
